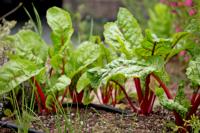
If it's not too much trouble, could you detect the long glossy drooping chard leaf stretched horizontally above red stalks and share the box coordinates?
[88,58,157,88]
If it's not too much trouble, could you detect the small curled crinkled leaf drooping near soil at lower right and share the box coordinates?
[156,88,188,117]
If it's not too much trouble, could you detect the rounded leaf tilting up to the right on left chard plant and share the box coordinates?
[65,42,100,78]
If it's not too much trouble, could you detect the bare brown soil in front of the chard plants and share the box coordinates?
[0,107,173,133]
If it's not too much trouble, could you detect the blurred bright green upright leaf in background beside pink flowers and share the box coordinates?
[148,3,173,37]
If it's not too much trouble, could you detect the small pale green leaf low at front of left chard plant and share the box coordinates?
[47,75,71,93]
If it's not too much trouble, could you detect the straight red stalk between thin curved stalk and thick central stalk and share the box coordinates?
[133,78,143,104]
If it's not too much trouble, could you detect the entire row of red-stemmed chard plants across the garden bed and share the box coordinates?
[0,4,200,132]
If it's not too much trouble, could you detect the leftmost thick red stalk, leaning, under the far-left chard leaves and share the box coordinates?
[31,77,46,109]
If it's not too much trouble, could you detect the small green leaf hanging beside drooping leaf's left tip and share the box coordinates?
[76,72,90,93]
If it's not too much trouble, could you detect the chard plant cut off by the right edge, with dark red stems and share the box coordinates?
[156,58,200,130]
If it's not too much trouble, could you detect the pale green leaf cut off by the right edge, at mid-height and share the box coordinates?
[186,58,200,85]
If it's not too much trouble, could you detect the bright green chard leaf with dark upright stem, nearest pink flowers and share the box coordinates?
[135,30,188,60]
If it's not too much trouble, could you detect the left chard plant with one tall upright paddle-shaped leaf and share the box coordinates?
[0,7,100,112]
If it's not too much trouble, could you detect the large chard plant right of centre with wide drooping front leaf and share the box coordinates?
[87,8,188,114]
